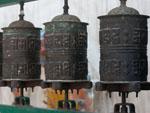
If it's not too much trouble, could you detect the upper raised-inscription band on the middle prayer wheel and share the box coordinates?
[46,32,87,50]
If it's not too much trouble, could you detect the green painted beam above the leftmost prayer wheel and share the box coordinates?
[0,0,36,7]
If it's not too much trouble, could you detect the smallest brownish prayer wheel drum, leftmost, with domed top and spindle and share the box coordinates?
[3,2,41,80]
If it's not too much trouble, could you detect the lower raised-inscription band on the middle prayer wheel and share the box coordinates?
[45,61,88,80]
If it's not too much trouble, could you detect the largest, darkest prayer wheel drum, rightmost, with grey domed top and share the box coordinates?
[99,0,149,81]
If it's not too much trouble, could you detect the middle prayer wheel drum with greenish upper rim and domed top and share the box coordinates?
[45,0,88,80]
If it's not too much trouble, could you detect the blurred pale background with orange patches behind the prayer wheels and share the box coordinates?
[0,0,150,113]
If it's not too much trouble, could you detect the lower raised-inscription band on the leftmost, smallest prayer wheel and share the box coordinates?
[3,61,41,80]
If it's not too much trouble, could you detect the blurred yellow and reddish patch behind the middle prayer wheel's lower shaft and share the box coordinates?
[45,88,93,112]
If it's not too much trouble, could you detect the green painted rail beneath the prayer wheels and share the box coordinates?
[0,105,90,113]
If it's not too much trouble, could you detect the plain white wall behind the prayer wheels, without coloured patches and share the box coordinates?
[0,0,150,113]
